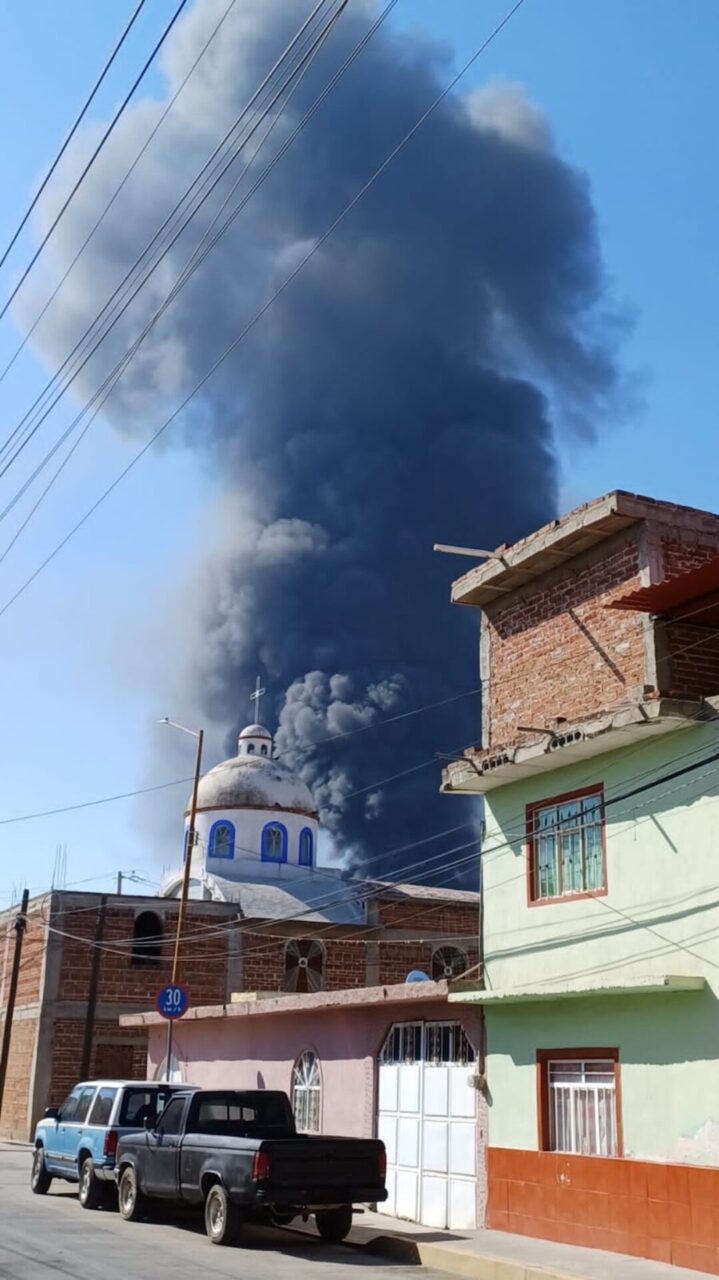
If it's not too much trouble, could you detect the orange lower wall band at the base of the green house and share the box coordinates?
[486,1147,719,1275]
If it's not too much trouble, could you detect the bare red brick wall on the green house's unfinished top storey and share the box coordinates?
[484,530,646,746]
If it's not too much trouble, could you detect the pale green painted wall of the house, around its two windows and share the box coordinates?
[482,724,719,1165]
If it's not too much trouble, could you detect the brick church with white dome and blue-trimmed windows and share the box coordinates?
[0,724,478,1138]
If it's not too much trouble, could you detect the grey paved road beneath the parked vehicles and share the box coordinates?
[0,1143,447,1280]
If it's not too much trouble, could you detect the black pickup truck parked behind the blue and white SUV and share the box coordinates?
[115,1089,386,1244]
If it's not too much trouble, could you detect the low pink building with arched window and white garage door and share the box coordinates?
[122,982,486,1228]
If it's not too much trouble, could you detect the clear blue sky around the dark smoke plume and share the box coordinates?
[0,0,719,905]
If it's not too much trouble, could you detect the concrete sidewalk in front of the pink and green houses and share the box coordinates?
[298,1213,706,1280]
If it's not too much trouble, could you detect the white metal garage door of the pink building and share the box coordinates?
[377,1023,477,1228]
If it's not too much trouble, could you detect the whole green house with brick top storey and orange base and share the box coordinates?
[443,493,719,1274]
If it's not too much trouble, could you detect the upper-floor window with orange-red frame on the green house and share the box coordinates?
[527,787,606,902]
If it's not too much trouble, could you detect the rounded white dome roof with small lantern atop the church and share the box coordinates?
[188,724,317,817]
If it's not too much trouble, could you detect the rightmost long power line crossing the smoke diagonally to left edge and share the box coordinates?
[0,0,525,617]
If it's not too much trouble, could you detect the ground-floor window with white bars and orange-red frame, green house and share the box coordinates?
[541,1056,619,1156]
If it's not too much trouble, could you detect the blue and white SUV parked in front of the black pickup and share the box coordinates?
[31,1080,182,1208]
